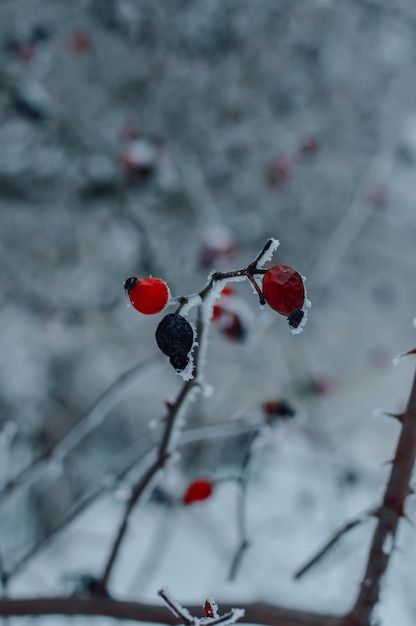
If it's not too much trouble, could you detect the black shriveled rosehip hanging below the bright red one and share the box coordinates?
[156,313,194,369]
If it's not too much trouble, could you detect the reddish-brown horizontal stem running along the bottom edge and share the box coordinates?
[0,596,341,626]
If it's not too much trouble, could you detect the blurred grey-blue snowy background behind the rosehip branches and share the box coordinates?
[0,0,416,626]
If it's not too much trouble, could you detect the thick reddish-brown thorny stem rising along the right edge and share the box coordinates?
[342,364,416,626]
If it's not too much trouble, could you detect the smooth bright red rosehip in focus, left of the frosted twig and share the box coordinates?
[124,276,170,315]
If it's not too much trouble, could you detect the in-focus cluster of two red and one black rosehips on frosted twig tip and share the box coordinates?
[124,239,309,372]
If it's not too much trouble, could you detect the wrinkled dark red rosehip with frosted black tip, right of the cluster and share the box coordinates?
[262,265,305,314]
